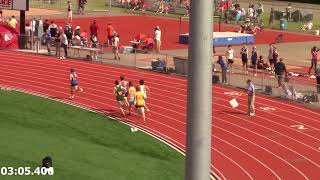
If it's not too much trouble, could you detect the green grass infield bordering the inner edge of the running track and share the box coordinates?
[0,91,184,180]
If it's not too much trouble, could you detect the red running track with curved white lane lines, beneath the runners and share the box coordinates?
[0,51,320,180]
